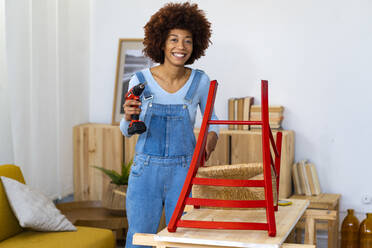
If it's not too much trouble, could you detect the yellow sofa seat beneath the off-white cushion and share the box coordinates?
[0,226,115,248]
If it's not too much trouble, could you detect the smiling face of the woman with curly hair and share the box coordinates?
[163,29,193,66]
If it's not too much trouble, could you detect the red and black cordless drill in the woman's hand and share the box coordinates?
[125,83,146,135]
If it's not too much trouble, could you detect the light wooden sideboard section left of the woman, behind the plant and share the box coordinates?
[73,123,123,201]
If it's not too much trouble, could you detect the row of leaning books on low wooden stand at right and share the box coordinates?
[292,160,321,196]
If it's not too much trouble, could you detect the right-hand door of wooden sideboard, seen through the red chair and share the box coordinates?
[229,130,294,198]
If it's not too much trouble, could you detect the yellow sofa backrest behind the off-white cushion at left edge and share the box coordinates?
[0,165,25,242]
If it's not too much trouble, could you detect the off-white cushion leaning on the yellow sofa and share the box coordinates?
[1,176,76,231]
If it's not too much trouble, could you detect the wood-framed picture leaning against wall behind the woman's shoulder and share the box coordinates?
[112,39,153,125]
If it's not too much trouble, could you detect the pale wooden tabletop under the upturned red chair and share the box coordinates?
[155,200,309,248]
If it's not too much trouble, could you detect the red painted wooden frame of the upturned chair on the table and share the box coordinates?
[168,80,282,236]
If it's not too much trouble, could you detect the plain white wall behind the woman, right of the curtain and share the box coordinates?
[90,0,372,212]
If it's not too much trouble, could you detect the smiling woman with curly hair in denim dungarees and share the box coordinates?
[120,3,218,247]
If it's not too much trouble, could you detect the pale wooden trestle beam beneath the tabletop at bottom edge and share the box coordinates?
[133,233,315,248]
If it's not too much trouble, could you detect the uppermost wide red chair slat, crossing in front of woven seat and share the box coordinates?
[192,177,265,187]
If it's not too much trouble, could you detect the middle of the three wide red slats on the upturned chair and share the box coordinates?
[186,198,266,208]
